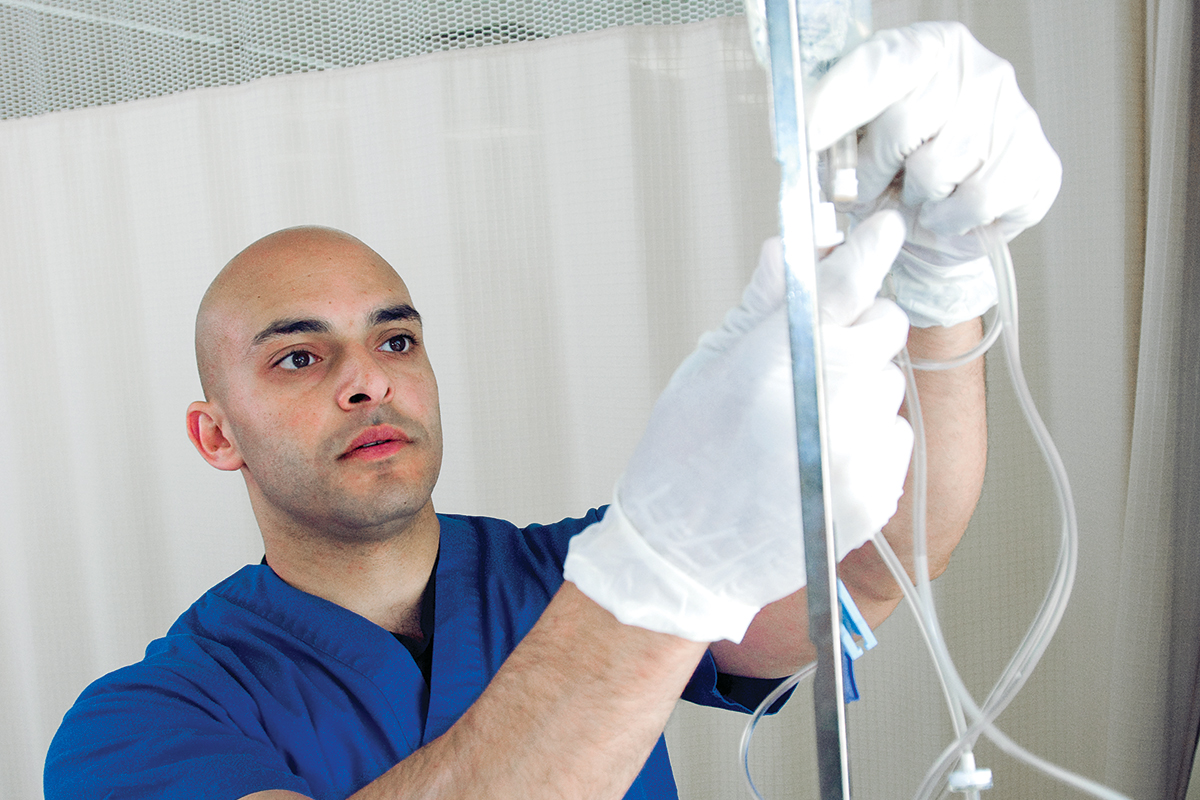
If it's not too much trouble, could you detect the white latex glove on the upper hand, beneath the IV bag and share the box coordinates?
[805,23,1062,327]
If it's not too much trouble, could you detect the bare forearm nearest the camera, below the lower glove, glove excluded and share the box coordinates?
[244,583,706,800]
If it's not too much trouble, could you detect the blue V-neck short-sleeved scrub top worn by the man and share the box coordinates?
[44,509,776,800]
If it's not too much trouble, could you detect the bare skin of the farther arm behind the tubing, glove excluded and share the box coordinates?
[712,320,988,678]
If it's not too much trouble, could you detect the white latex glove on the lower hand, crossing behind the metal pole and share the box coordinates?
[564,212,912,642]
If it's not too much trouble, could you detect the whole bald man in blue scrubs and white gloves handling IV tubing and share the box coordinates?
[46,20,1057,800]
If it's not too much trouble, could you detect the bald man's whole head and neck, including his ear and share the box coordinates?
[187,228,442,638]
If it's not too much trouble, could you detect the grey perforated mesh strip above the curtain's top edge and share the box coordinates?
[0,0,742,119]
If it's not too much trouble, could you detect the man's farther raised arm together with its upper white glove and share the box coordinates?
[713,15,1062,676]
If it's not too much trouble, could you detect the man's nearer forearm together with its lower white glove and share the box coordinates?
[246,225,907,800]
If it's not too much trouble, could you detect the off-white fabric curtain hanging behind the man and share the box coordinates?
[0,0,1195,800]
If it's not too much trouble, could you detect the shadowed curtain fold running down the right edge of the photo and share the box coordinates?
[1106,1,1200,798]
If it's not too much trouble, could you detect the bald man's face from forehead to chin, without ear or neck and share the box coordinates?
[199,231,442,541]
